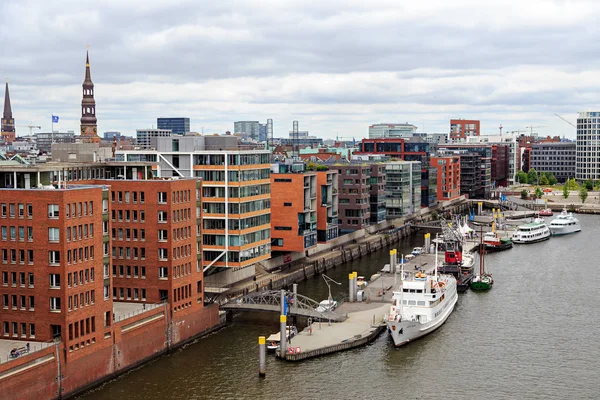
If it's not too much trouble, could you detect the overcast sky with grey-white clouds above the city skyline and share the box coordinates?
[0,0,600,139]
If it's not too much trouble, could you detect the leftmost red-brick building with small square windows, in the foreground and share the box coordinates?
[0,165,113,358]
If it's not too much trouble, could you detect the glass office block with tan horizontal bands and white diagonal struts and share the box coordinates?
[116,135,271,273]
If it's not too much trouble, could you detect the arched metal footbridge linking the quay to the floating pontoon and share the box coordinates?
[221,290,347,322]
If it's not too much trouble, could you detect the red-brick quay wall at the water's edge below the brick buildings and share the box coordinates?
[0,305,224,400]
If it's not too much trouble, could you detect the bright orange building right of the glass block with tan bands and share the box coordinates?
[271,163,317,252]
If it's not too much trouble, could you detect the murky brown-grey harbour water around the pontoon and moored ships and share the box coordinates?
[81,215,600,400]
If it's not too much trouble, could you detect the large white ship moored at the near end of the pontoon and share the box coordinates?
[386,244,458,347]
